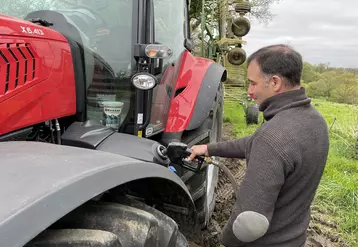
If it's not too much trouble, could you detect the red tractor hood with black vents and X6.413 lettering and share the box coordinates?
[0,15,76,135]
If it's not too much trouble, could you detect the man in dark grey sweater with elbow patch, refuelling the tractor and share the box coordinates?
[189,45,329,247]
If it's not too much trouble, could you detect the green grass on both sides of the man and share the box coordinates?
[224,94,358,246]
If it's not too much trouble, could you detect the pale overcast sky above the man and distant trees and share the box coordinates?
[243,0,358,68]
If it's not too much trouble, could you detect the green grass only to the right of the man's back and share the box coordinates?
[313,100,358,246]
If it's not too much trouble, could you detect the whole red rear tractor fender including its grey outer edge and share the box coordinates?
[164,52,226,134]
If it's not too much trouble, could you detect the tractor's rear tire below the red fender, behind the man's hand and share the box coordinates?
[185,84,224,229]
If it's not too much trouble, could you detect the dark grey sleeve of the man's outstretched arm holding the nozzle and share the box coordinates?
[208,136,251,159]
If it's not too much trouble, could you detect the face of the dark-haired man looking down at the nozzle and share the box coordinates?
[247,61,276,104]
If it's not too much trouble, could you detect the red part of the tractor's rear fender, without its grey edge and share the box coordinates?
[165,51,214,132]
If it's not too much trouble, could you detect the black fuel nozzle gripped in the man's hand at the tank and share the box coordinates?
[165,142,204,172]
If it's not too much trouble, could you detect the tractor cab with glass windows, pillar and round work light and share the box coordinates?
[2,0,189,137]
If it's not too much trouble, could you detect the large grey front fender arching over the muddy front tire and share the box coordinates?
[0,142,194,247]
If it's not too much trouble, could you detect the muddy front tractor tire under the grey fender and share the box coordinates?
[25,199,188,247]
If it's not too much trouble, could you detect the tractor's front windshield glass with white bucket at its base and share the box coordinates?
[0,0,134,129]
